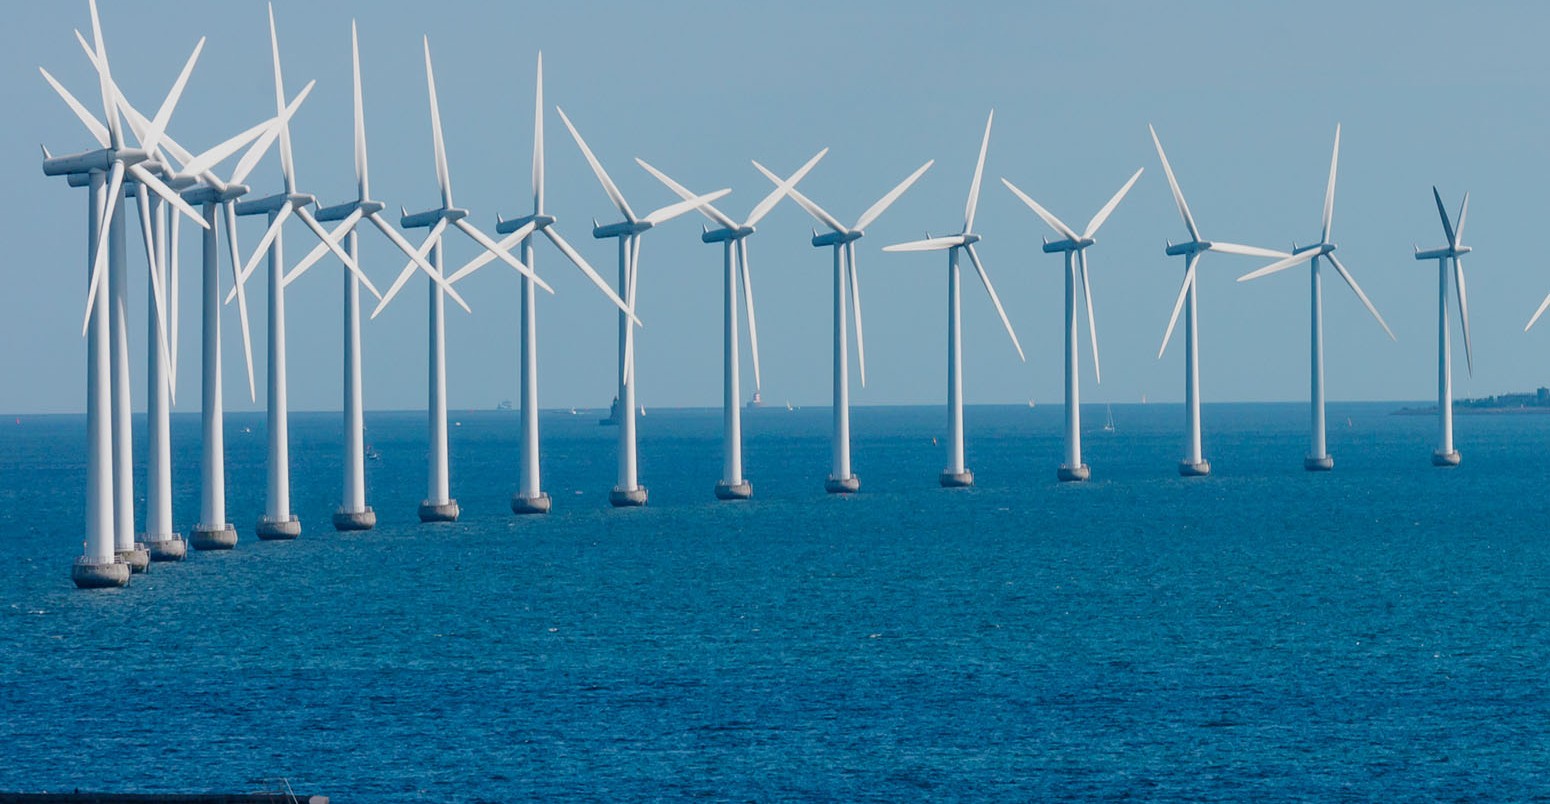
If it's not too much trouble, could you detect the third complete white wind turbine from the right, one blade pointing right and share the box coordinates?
[1147,125,1288,477]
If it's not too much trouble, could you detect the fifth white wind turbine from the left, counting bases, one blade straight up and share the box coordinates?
[226,6,384,539]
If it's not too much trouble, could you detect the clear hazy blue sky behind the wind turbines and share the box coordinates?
[0,0,1550,412]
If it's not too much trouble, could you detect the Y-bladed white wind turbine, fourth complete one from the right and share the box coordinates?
[1001,167,1145,483]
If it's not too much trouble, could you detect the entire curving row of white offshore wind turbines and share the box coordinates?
[40,0,1531,587]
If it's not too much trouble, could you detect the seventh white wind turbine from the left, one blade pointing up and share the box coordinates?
[372,37,553,522]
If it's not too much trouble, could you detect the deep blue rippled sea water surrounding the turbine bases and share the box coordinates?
[0,404,1550,801]
